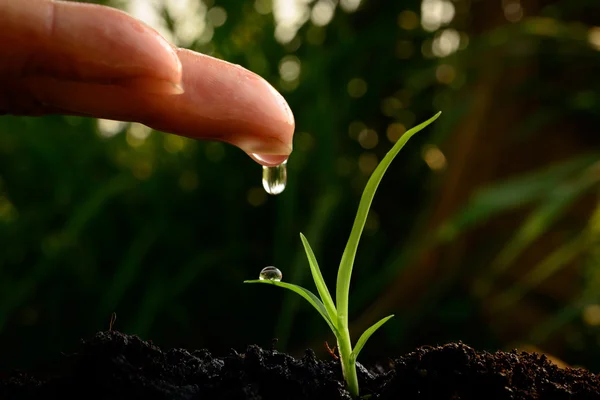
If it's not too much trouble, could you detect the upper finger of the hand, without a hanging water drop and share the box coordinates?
[0,0,181,84]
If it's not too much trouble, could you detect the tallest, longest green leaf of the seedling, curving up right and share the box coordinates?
[336,112,441,322]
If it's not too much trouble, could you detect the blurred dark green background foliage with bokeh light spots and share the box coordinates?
[0,0,600,371]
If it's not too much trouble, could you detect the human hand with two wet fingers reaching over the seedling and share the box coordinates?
[0,0,294,166]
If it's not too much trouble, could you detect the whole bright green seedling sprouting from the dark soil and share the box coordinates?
[244,112,441,397]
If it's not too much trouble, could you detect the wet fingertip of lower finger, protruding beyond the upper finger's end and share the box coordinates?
[156,49,295,159]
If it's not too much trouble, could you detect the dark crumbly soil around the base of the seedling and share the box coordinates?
[0,331,600,400]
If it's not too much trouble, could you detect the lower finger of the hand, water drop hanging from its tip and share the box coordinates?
[24,49,294,158]
